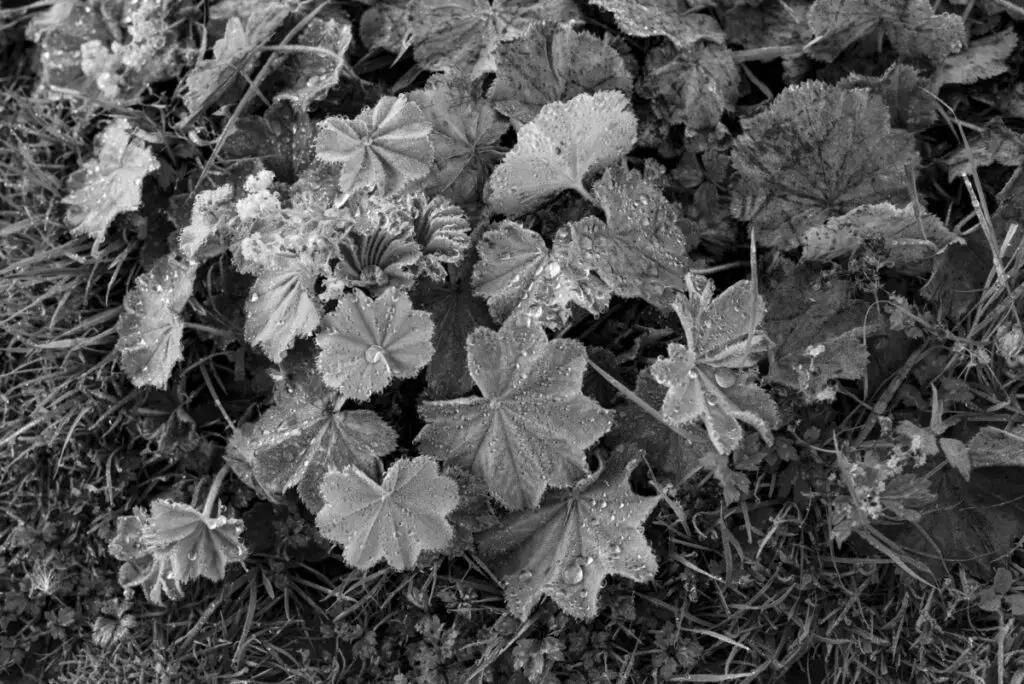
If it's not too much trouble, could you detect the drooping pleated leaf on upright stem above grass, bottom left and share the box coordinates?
[142,499,246,584]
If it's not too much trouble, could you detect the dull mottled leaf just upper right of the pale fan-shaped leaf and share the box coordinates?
[637,43,740,132]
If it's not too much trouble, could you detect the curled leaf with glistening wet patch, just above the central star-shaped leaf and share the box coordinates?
[473,221,610,328]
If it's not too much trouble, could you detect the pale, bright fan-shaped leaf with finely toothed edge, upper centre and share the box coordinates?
[486,90,637,217]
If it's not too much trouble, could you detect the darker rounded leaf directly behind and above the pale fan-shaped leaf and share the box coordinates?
[487,24,633,128]
